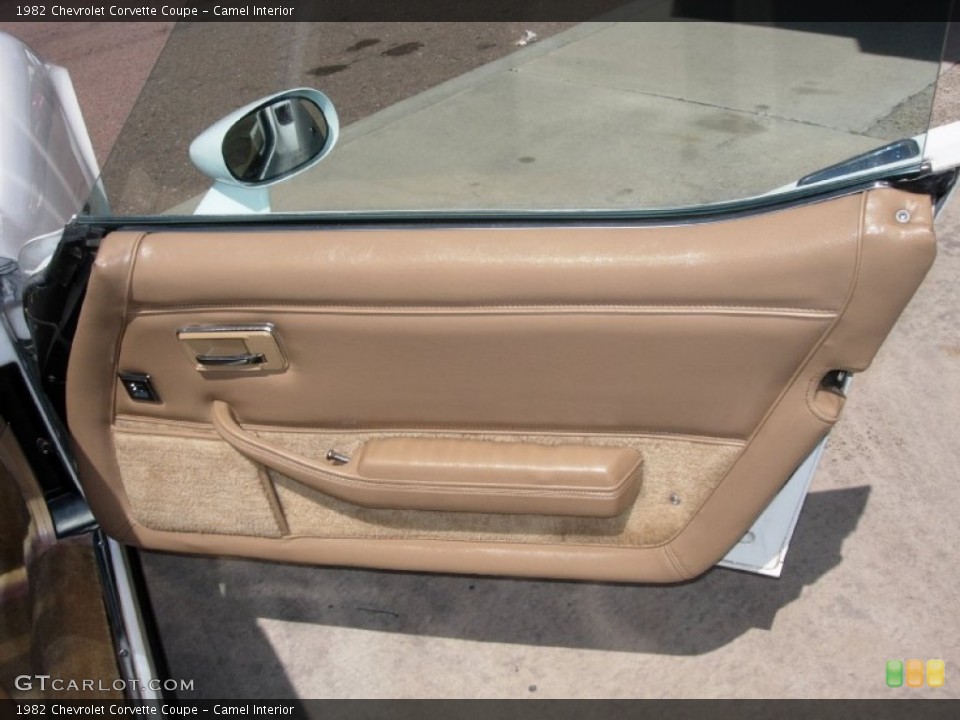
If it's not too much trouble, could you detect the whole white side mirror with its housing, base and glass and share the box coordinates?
[190,88,340,214]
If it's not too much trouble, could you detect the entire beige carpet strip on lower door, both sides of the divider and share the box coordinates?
[114,418,744,547]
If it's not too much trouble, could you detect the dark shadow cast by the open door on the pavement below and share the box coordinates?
[143,487,870,698]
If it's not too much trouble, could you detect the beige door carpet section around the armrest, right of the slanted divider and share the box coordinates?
[266,432,743,547]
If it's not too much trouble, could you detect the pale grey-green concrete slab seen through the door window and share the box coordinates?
[272,18,939,211]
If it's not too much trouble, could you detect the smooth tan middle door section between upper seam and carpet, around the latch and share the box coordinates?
[117,307,836,439]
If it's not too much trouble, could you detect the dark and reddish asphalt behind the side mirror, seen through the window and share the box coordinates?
[0,22,572,214]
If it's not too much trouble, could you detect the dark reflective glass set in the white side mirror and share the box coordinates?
[223,97,328,183]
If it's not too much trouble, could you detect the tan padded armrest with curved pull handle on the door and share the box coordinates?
[212,400,643,517]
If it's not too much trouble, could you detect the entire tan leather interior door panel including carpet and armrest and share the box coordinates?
[68,189,935,582]
